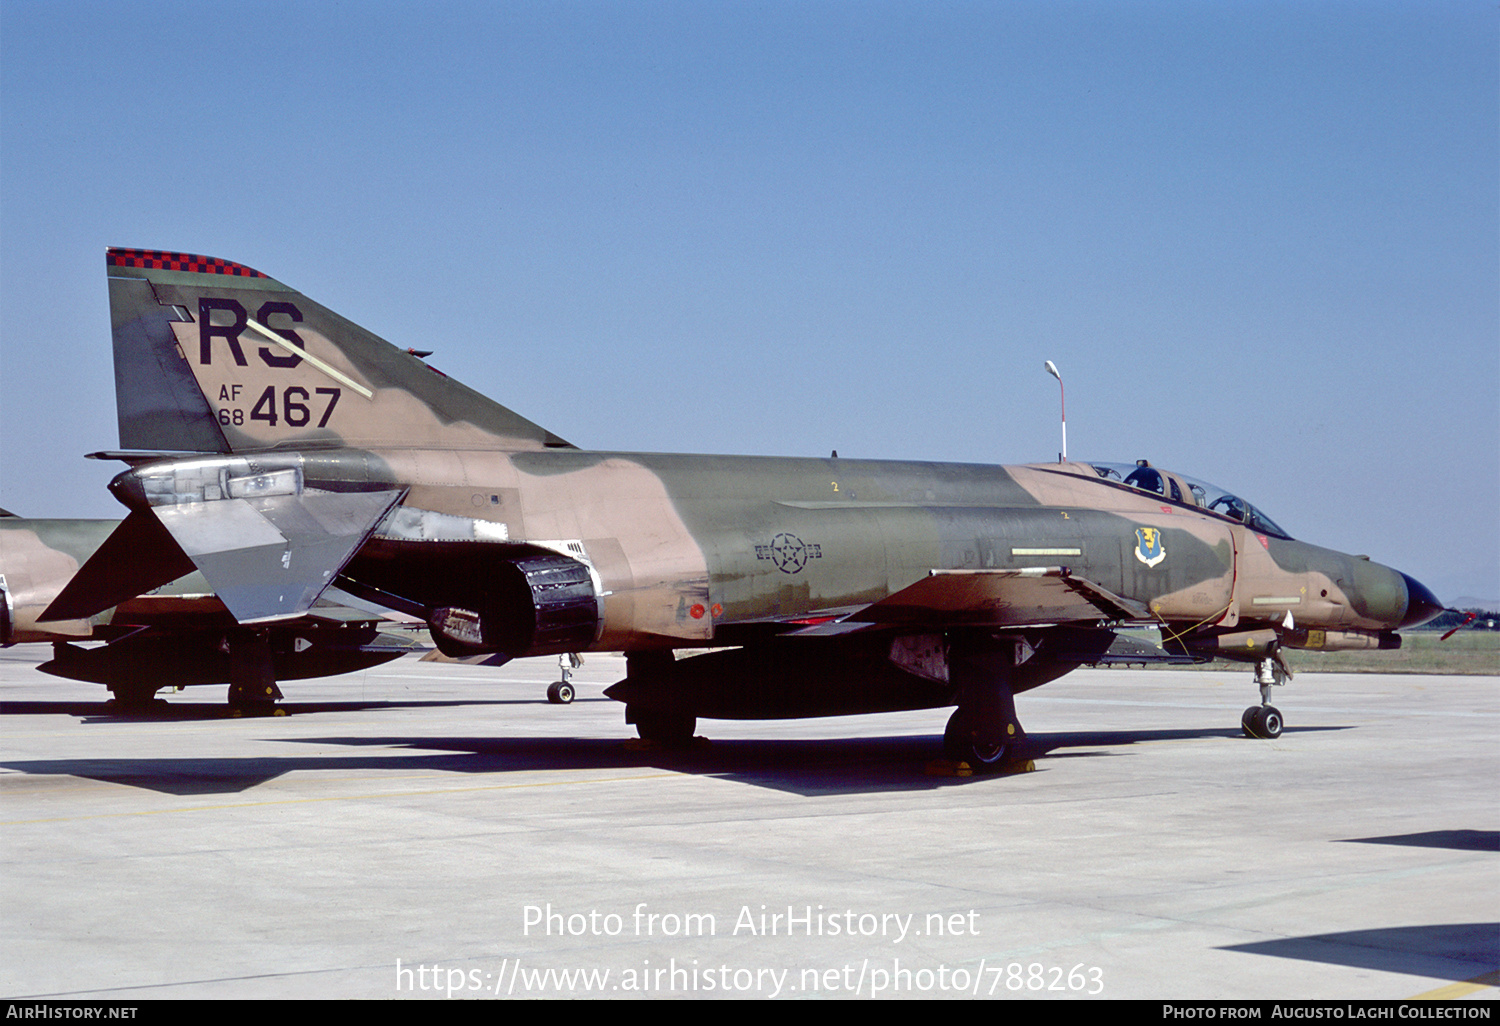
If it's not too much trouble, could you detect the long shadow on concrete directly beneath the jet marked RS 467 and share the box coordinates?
[0,717,1338,797]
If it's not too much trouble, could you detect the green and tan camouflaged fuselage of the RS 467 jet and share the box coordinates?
[102,450,1407,654]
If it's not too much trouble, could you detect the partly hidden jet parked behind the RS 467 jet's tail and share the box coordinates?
[0,510,413,711]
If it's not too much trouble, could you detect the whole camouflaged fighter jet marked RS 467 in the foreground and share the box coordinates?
[45,249,1442,767]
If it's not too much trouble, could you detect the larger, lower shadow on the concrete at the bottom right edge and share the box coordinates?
[1221,923,1500,986]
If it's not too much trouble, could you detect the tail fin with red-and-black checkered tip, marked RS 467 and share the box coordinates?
[105,249,570,453]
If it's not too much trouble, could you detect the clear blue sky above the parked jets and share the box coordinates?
[0,0,1500,602]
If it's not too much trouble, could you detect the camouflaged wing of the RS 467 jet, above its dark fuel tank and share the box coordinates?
[794,567,1152,636]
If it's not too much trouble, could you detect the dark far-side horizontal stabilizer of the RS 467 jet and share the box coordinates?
[41,512,194,621]
